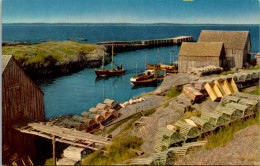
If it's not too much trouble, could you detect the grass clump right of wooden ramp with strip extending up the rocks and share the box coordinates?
[82,109,156,165]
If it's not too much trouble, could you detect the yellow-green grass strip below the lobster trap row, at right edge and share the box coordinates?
[203,110,259,149]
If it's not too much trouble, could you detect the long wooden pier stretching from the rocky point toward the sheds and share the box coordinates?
[96,36,193,52]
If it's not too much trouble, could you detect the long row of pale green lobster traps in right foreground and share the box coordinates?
[154,92,260,164]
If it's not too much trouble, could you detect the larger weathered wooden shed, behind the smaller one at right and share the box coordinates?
[198,30,251,68]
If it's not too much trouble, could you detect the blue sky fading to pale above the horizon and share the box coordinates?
[2,0,260,24]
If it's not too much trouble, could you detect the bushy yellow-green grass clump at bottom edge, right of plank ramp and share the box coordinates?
[81,136,143,165]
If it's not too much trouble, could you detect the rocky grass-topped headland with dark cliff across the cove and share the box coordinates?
[2,42,111,79]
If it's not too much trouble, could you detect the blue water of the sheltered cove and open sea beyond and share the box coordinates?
[2,24,259,119]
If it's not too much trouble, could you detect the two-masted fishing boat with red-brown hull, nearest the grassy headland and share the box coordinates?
[95,45,125,76]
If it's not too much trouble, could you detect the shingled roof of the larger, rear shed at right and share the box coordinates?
[198,30,249,50]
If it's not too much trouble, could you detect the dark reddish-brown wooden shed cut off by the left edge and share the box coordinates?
[2,55,45,162]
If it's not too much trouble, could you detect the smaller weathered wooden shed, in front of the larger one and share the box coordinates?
[178,42,225,72]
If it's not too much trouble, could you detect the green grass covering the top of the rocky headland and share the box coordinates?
[2,41,95,65]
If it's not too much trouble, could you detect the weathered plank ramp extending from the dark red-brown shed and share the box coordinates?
[13,123,111,150]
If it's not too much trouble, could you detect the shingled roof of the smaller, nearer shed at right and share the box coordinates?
[179,42,223,57]
